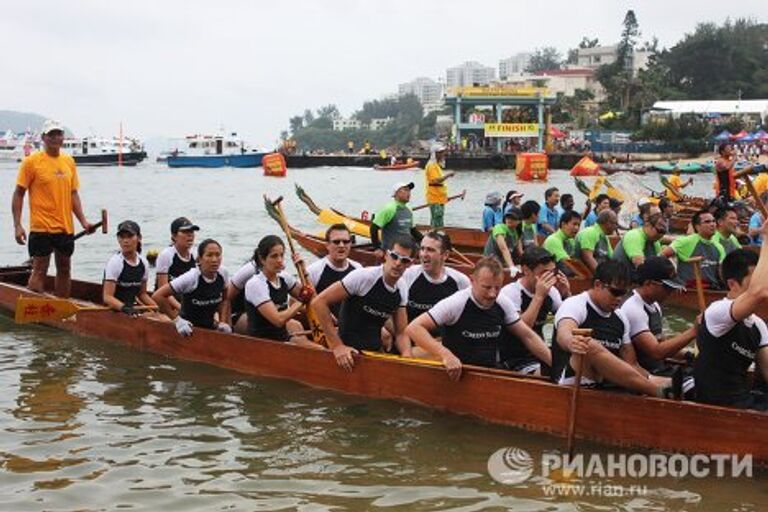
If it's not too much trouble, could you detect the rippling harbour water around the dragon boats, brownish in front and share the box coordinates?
[0,164,768,511]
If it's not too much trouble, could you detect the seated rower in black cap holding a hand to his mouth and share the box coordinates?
[499,247,571,374]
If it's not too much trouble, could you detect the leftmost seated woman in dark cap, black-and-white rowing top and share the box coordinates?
[102,220,157,316]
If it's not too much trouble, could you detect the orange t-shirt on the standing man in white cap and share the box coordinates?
[16,151,80,235]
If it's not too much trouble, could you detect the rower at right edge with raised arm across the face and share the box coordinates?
[693,244,768,411]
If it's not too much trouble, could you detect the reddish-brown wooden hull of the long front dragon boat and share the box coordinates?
[0,277,768,464]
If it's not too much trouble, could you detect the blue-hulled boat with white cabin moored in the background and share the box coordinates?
[166,133,266,168]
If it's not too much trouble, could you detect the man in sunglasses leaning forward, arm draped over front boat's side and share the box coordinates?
[313,237,416,371]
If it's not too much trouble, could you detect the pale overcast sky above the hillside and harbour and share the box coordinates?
[0,0,768,149]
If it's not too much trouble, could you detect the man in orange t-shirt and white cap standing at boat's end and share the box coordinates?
[11,120,93,298]
